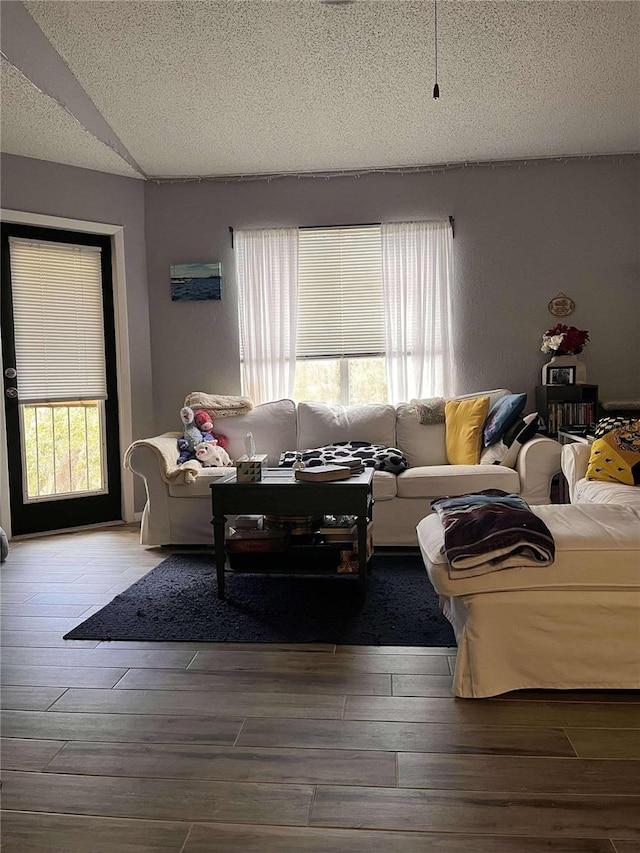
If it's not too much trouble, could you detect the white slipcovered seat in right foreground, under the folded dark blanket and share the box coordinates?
[417,502,640,698]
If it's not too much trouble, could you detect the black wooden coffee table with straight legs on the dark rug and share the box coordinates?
[211,468,373,599]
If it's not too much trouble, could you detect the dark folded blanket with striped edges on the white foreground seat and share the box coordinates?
[431,489,555,577]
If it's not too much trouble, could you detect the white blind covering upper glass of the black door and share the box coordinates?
[9,237,107,403]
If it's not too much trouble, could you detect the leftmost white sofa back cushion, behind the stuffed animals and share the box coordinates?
[218,400,296,468]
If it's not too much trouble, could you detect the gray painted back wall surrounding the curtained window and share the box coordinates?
[145,157,640,431]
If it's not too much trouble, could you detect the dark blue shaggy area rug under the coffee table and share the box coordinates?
[65,554,455,646]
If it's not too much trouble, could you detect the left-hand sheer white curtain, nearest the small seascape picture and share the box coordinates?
[234,228,298,403]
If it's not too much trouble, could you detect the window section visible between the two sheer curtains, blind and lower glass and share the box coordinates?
[294,225,387,405]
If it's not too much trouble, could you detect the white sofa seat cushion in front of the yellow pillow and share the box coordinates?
[396,465,520,500]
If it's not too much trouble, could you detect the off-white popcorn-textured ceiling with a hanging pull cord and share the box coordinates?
[2,0,640,177]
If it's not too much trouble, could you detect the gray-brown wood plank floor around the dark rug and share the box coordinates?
[0,526,640,853]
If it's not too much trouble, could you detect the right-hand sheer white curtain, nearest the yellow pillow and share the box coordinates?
[382,221,455,403]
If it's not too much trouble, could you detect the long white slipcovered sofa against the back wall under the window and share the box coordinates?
[125,389,561,546]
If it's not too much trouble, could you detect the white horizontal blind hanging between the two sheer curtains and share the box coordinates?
[296,225,385,358]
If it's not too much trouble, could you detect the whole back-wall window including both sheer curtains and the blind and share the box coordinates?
[236,220,454,405]
